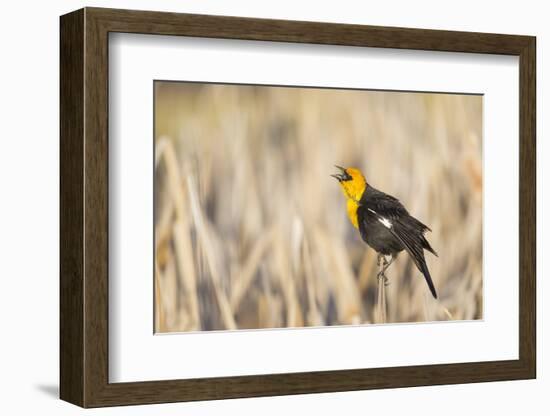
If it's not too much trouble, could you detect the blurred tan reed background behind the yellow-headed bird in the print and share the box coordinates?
[155,82,482,332]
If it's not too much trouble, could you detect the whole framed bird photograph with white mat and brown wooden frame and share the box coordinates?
[60,8,536,407]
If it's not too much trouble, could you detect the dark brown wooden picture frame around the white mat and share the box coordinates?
[60,8,536,407]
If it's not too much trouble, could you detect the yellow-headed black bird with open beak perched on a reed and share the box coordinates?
[331,165,438,299]
